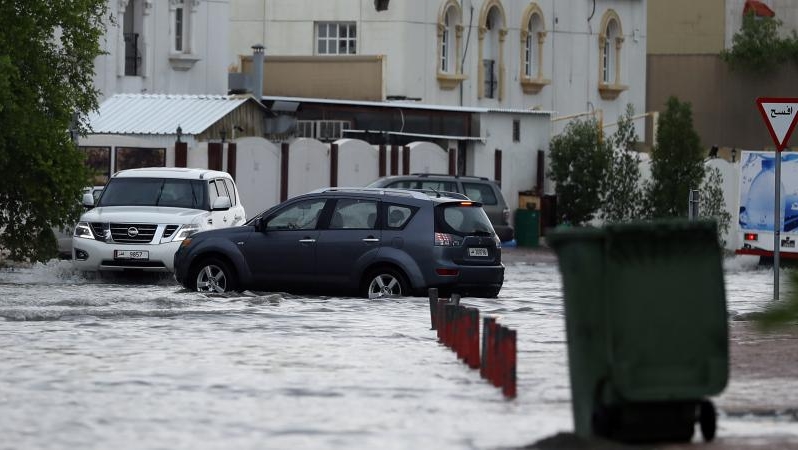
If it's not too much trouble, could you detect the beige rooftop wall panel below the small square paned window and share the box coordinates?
[241,55,385,101]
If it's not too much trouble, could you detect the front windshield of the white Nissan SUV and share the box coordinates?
[97,178,207,209]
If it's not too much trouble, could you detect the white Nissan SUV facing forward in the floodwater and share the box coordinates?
[72,167,246,272]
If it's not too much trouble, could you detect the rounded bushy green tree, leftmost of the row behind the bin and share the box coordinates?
[548,119,611,225]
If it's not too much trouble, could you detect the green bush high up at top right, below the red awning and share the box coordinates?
[720,13,798,74]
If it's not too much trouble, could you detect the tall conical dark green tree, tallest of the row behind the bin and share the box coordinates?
[645,97,704,219]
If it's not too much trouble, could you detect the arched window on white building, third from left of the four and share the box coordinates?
[520,3,550,94]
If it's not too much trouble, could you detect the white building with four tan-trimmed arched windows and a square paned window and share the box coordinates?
[229,0,646,136]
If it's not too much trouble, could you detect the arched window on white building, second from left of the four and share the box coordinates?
[478,0,507,101]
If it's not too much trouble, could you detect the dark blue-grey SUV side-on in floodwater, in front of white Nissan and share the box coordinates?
[174,188,504,298]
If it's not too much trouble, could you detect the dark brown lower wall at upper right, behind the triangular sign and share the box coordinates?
[646,55,798,150]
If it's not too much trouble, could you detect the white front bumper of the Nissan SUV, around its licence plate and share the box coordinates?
[72,238,180,272]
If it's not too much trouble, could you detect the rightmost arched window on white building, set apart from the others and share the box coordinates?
[598,9,627,100]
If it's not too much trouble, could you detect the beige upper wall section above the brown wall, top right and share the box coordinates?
[648,0,726,55]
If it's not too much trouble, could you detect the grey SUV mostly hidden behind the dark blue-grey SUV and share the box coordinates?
[368,173,515,242]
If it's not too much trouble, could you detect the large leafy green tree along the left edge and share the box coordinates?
[0,0,107,261]
